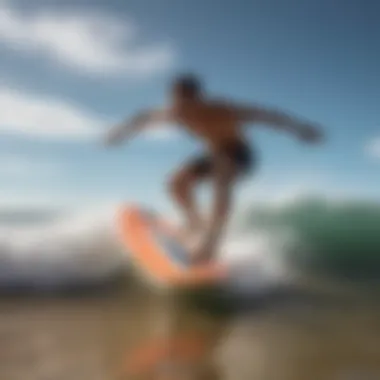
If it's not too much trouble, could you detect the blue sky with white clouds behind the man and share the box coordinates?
[0,0,380,206]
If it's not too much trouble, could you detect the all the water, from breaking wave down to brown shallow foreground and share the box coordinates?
[0,200,380,380]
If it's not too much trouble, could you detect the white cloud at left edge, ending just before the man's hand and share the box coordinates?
[0,87,102,139]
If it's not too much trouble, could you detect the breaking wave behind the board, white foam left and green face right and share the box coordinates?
[0,199,380,291]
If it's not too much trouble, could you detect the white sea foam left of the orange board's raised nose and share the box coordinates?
[0,209,125,286]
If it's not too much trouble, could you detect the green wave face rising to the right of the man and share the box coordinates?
[240,199,380,282]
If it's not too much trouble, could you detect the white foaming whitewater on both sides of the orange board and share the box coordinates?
[0,206,285,291]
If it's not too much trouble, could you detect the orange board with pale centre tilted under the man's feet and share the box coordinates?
[117,206,228,287]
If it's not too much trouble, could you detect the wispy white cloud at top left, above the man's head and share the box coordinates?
[0,2,175,77]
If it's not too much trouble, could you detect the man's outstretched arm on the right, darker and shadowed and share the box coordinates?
[235,106,322,141]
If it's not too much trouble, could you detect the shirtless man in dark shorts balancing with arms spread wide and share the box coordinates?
[106,75,321,262]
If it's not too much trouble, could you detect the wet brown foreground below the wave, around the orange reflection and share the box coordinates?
[0,284,380,380]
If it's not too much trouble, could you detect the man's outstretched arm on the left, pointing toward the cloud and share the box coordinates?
[105,110,171,145]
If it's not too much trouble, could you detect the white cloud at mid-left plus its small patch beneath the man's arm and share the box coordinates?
[0,86,181,142]
